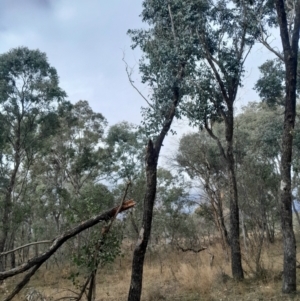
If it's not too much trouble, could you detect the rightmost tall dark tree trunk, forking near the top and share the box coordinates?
[275,0,300,293]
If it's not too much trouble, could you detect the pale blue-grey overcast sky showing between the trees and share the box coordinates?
[0,0,282,162]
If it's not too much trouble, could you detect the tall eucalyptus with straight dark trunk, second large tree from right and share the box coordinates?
[157,0,257,279]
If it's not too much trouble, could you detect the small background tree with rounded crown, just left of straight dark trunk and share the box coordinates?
[176,130,230,250]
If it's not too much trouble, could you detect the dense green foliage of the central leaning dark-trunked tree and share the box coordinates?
[128,1,194,137]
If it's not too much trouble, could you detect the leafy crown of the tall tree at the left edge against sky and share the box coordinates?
[0,47,66,159]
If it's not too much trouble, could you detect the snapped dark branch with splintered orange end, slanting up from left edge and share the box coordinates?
[0,200,135,280]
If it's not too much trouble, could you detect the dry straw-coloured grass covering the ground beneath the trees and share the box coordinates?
[0,237,300,301]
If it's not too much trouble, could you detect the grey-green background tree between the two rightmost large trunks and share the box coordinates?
[235,103,283,253]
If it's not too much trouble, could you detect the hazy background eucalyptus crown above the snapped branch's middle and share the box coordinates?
[31,101,106,236]
